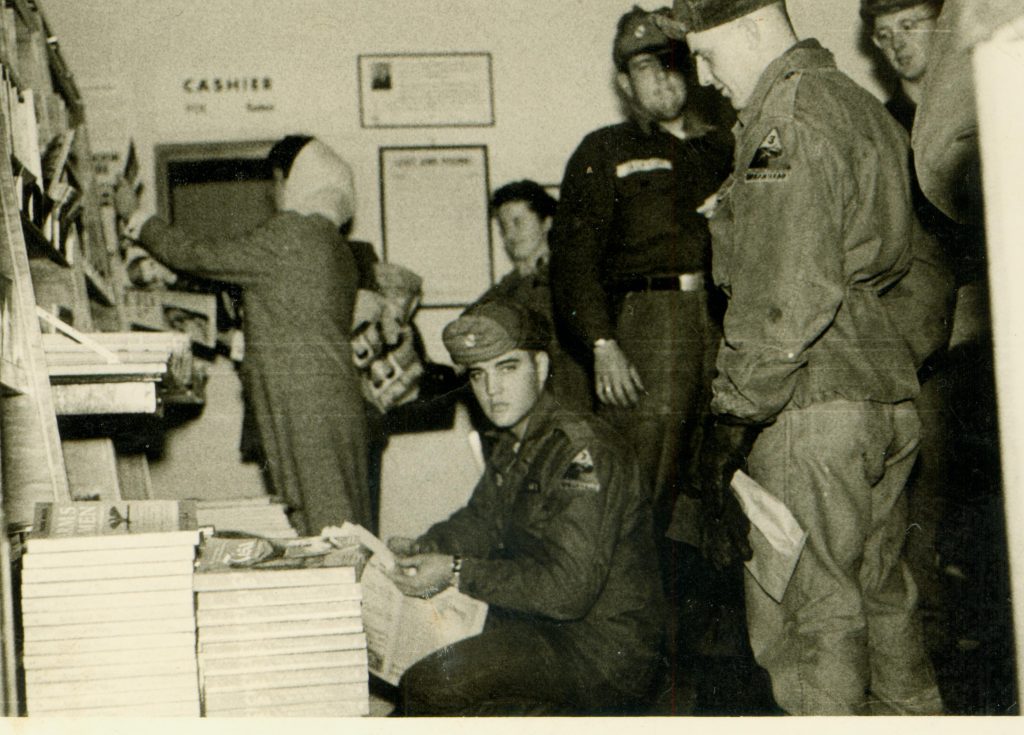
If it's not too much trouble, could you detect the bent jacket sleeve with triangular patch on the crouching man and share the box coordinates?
[459,441,622,620]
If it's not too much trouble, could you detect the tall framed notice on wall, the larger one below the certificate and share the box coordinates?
[380,145,494,306]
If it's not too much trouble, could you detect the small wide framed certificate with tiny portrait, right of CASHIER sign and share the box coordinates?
[358,53,495,128]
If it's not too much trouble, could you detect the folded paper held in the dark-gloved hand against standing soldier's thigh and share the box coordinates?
[669,470,807,602]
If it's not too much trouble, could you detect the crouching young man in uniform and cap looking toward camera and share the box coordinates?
[389,300,665,716]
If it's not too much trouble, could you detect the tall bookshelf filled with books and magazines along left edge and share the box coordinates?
[0,0,190,716]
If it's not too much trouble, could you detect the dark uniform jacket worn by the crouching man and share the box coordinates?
[419,394,664,689]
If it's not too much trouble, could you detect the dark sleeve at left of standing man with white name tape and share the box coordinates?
[551,139,615,348]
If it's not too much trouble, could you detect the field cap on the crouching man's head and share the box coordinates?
[441,299,551,365]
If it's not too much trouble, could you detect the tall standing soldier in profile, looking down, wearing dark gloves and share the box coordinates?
[663,0,942,715]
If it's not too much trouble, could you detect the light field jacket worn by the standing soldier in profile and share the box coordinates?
[711,40,918,422]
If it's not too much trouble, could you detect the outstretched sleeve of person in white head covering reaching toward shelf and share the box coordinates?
[130,217,291,286]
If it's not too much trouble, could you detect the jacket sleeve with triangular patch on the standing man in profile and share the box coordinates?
[712,118,856,423]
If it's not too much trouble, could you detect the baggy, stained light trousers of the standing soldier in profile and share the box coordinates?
[745,401,942,715]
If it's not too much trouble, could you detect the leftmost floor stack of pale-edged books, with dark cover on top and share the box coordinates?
[20,501,200,717]
